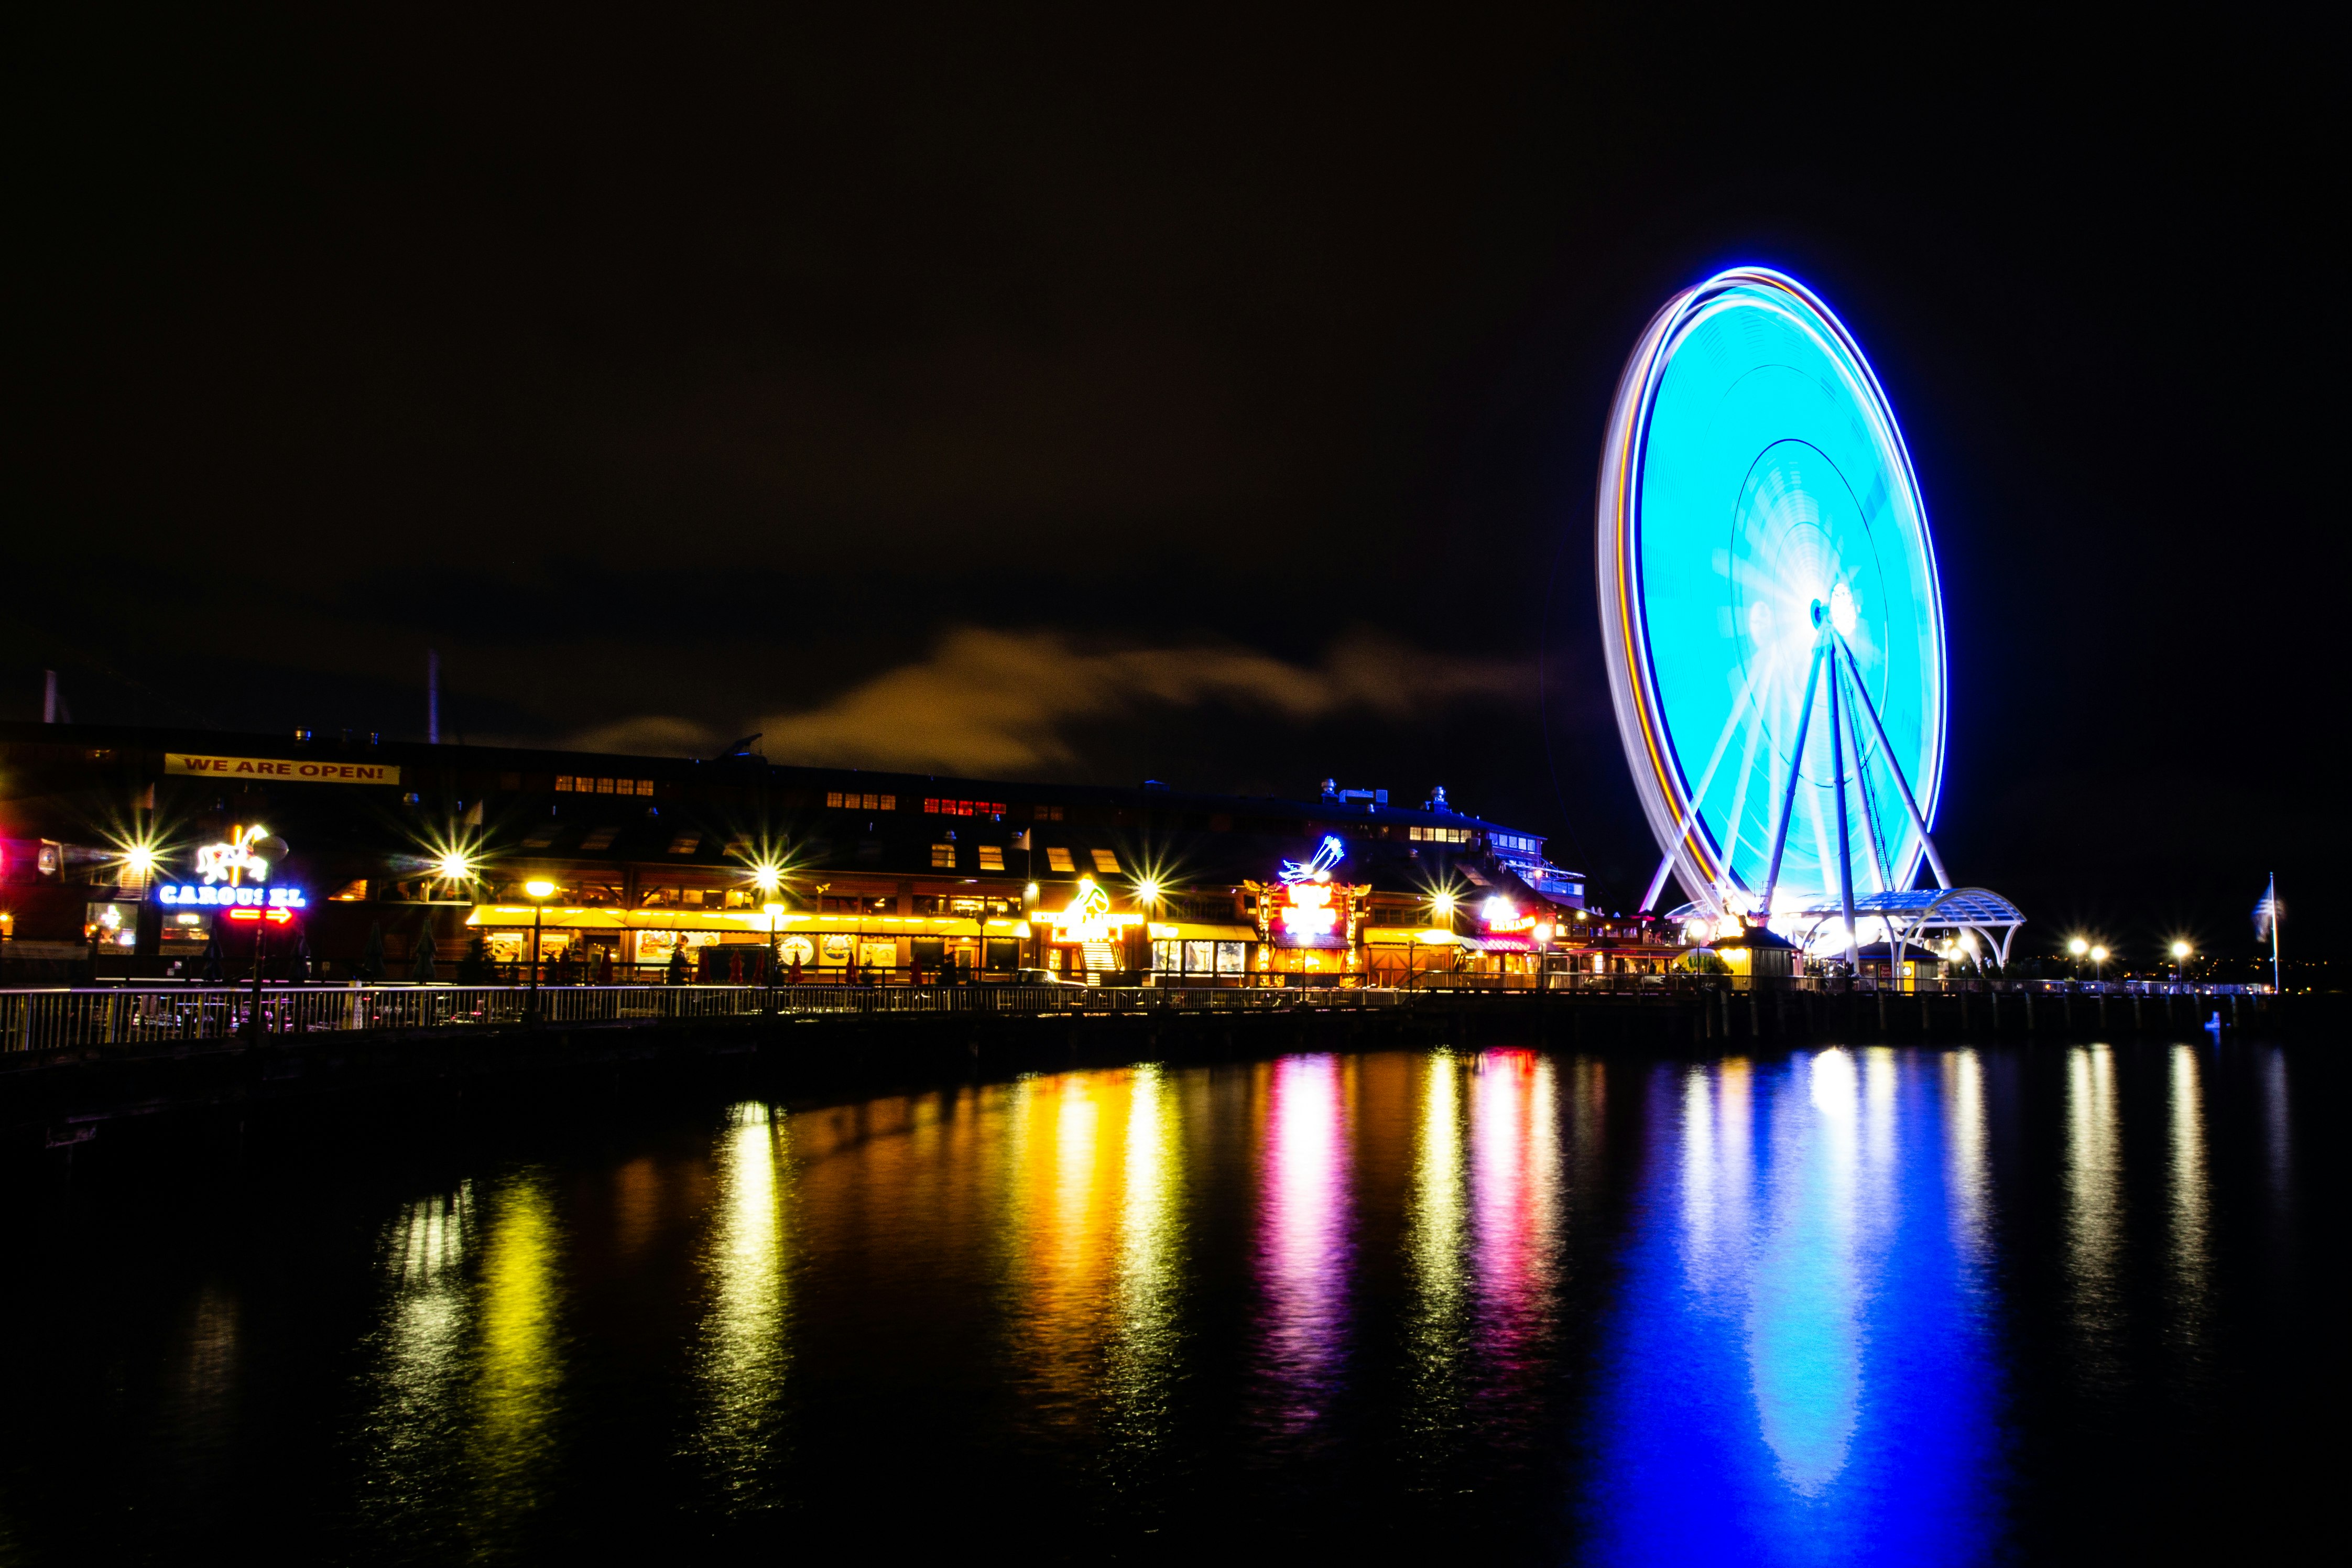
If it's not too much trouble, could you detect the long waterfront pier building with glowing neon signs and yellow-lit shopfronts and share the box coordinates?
[0,724,1585,985]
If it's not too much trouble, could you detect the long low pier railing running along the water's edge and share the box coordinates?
[0,973,2267,1055]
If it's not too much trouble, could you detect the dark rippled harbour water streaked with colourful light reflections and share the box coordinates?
[0,1044,2347,1563]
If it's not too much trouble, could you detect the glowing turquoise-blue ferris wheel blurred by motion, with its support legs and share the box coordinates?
[1597,268,2023,957]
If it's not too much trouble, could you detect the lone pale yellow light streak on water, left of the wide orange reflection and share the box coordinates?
[696,1103,790,1502]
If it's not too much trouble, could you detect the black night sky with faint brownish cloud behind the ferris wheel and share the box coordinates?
[0,5,2345,954]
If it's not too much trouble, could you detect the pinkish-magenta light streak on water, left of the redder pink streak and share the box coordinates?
[1258,1055,1350,1432]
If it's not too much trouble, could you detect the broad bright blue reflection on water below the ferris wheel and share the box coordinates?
[1587,1051,1995,1563]
